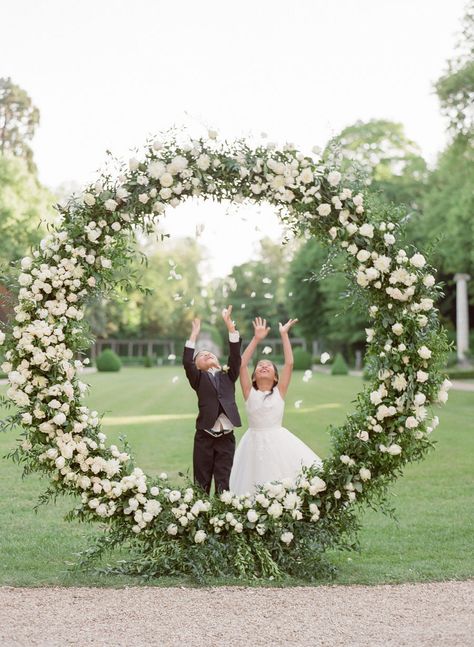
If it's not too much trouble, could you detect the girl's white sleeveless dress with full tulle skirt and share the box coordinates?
[229,387,322,494]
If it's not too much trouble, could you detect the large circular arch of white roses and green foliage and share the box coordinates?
[0,133,450,577]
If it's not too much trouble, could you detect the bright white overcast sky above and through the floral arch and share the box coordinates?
[0,0,465,278]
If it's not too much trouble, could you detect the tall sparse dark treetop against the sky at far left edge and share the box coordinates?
[0,78,40,172]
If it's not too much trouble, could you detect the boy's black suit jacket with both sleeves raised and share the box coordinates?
[183,339,242,429]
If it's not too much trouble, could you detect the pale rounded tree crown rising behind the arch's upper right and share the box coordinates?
[323,119,428,209]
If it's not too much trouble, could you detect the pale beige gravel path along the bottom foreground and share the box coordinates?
[0,580,474,647]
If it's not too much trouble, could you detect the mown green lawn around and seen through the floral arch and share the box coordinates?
[0,366,474,586]
